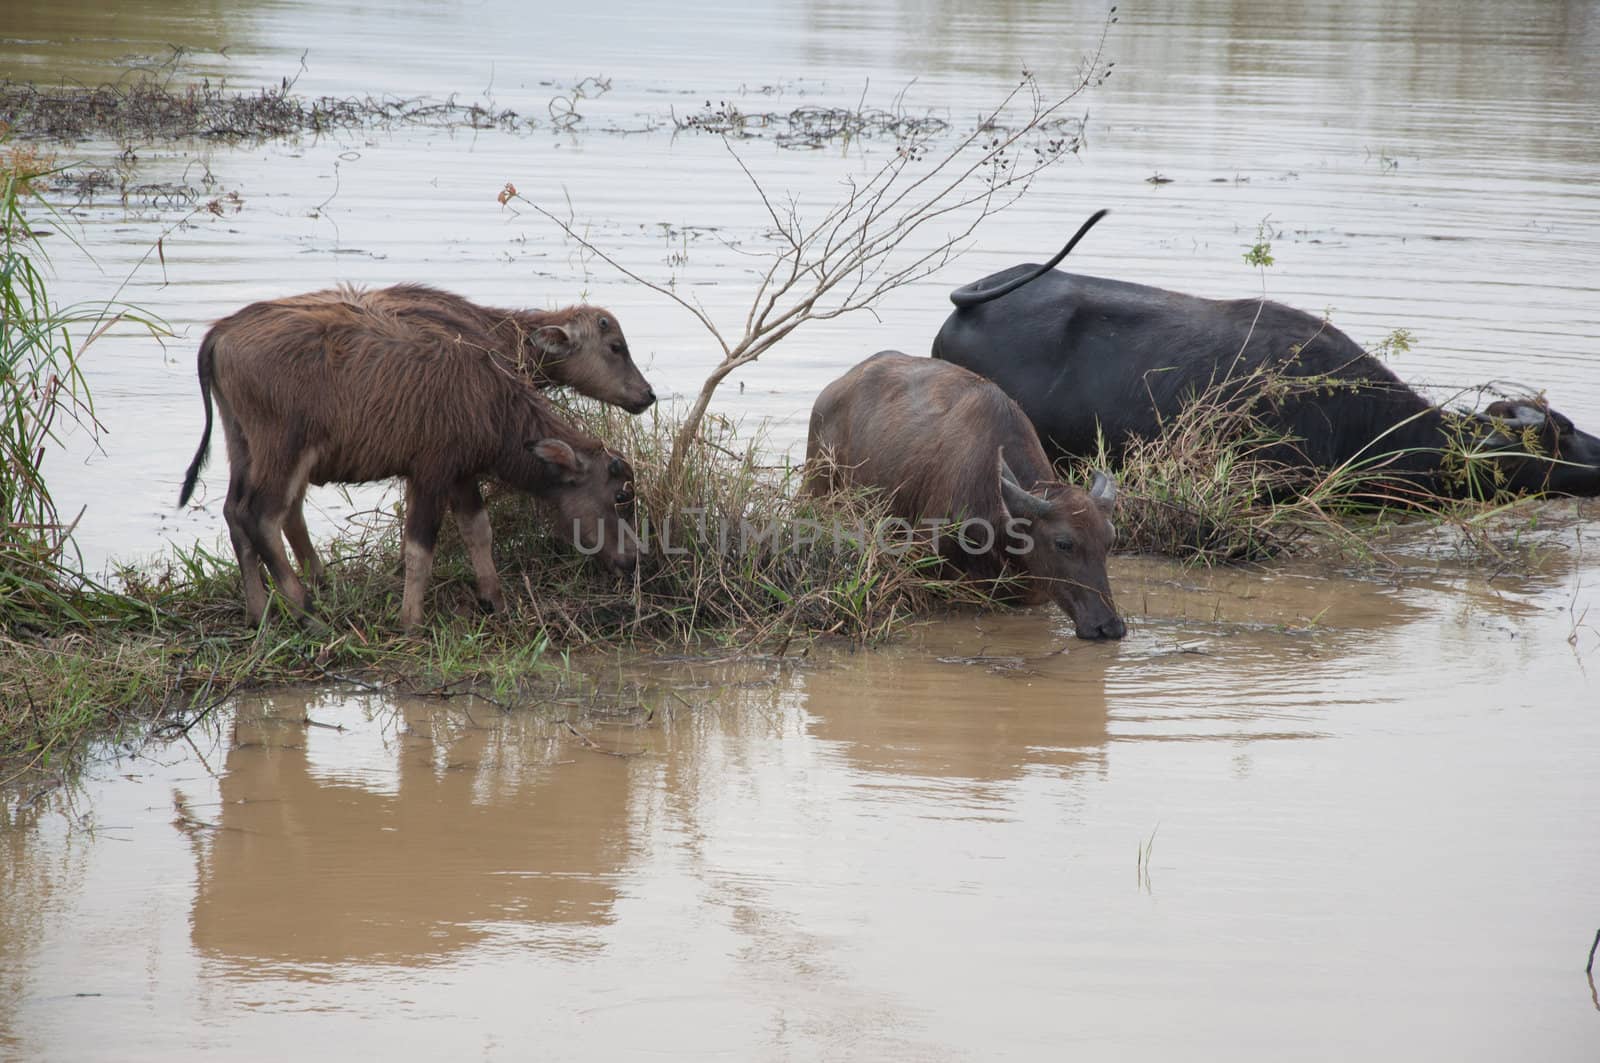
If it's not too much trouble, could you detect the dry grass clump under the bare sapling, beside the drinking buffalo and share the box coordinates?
[494,403,987,645]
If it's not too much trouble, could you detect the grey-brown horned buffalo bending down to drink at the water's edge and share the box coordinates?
[806,351,1126,639]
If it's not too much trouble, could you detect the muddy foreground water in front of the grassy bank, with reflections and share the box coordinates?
[0,562,1600,1060]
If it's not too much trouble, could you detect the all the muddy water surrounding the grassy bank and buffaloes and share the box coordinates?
[0,0,1600,1060]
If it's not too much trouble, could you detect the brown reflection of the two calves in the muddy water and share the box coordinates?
[192,695,629,973]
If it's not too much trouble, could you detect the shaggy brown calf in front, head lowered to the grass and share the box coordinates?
[179,292,637,628]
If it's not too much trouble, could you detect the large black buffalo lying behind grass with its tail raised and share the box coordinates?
[933,211,1600,495]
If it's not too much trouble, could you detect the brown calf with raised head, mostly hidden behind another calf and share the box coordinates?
[283,283,656,413]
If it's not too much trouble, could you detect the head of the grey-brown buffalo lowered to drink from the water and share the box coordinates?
[998,455,1128,639]
